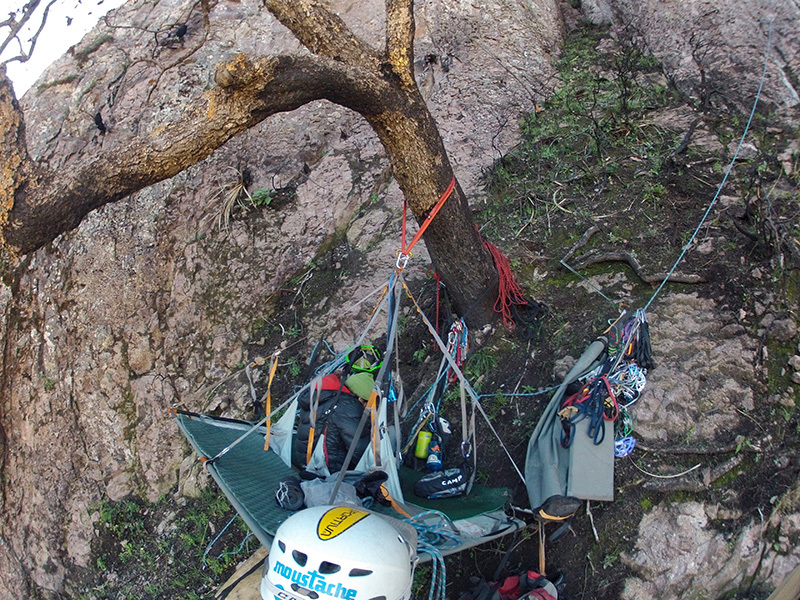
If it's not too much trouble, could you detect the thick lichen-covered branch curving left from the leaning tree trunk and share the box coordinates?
[0,54,396,255]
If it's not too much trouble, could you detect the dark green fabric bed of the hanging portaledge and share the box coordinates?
[175,411,522,554]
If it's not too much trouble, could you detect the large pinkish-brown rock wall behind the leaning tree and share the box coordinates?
[0,0,563,599]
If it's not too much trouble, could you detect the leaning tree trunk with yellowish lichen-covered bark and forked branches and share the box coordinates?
[0,0,504,324]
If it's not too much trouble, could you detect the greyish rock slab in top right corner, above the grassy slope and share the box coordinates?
[581,0,800,112]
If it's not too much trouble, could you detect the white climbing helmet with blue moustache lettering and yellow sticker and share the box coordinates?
[261,506,417,600]
